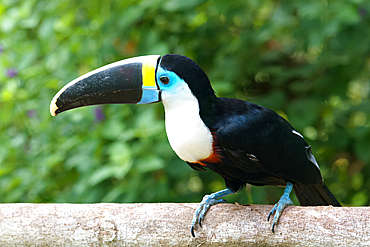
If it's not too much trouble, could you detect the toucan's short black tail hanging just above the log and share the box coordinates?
[293,184,341,207]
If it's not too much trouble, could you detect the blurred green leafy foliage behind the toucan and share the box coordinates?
[0,0,370,206]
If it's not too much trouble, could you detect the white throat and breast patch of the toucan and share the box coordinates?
[162,83,213,162]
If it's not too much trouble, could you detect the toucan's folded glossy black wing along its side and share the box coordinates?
[217,102,322,184]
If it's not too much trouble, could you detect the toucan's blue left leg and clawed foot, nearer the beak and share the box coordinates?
[190,189,235,237]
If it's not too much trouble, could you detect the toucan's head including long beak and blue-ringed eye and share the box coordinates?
[50,54,216,116]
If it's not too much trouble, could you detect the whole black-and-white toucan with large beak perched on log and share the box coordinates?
[50,54,341,237]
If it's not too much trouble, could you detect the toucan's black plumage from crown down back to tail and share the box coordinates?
[160,55,340,206]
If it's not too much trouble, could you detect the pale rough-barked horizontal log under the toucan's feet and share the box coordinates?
[0,203,370,247]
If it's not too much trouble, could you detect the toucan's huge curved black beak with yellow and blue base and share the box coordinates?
[50,55,161,116]
